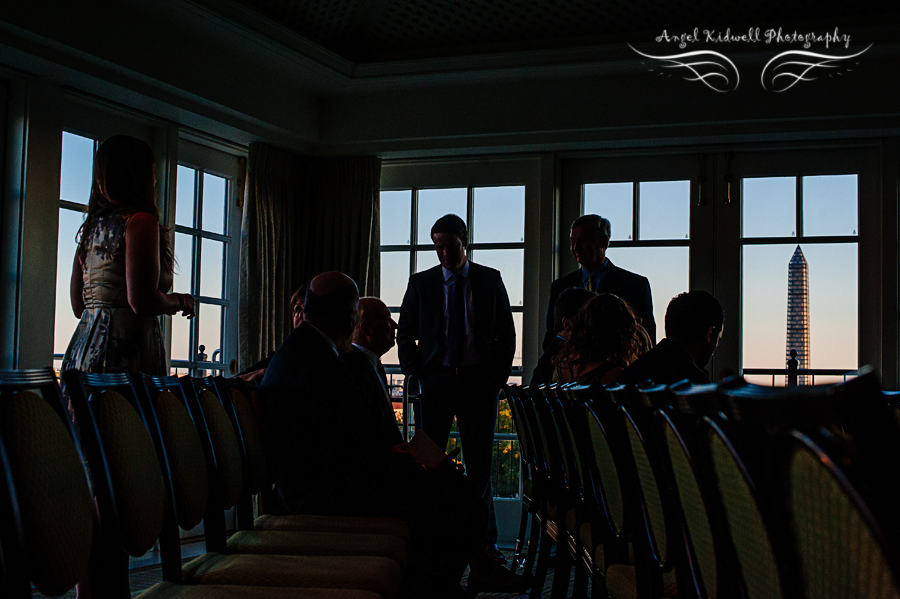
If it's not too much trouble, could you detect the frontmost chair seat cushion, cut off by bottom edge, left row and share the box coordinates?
[138,582,379,599]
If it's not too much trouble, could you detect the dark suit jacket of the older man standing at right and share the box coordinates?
[543,260,656,349]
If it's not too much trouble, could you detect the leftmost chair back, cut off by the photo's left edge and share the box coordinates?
[0,368,94,597]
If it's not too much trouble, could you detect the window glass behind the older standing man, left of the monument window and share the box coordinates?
[581,180,691,341]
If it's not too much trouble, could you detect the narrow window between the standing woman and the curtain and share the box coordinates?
[171,165,232,376]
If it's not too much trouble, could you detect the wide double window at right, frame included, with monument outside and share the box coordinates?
[559,145,876,385]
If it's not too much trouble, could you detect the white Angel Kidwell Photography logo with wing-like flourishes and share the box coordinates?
[628,27,872,93]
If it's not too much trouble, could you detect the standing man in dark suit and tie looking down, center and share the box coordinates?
[397,214,516,558]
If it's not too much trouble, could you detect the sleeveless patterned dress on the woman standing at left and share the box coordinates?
[62,210,173,375]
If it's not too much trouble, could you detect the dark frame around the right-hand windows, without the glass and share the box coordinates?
[558,140,884,378]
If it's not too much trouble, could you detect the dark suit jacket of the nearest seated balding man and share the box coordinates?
[259,323,414,515]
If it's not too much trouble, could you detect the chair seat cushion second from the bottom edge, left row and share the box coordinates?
[182,553,403,599]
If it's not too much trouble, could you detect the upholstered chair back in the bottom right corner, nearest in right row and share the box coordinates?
[787,431,900,599]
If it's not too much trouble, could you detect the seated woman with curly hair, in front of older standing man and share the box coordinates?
[550,293,644,385]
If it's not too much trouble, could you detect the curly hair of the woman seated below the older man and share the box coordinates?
[553,293,643,368]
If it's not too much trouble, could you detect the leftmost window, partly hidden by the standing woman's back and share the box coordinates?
[53,131,98,371]
